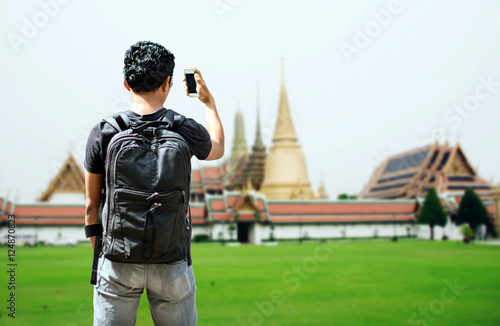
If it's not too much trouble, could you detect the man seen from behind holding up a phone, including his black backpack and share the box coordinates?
[84,42,224,325]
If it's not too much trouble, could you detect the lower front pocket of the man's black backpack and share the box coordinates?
[106,189,185,263]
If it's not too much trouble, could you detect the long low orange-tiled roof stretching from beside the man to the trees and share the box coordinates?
[207,191,418,224]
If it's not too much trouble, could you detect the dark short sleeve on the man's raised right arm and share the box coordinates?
[178,118,212,160]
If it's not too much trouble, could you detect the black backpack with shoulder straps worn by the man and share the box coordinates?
[91,110,192,284]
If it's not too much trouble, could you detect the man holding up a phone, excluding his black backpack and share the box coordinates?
[84,41,224,326]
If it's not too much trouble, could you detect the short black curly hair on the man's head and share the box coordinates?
[123,41,175,93]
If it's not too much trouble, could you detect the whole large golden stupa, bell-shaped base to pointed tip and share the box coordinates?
[261,62,316,199]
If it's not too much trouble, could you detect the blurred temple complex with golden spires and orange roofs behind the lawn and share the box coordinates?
[0,63,500,244]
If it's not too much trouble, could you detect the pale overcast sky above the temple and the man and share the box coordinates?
[0,0,500,202]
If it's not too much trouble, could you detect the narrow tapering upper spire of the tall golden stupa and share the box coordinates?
[273,58,297,143]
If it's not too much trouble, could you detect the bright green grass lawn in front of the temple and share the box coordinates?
[0,240,500,326]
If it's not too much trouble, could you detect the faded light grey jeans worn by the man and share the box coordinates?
[94,257,196,326]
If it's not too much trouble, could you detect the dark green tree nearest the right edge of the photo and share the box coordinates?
[457,188,491,234]
